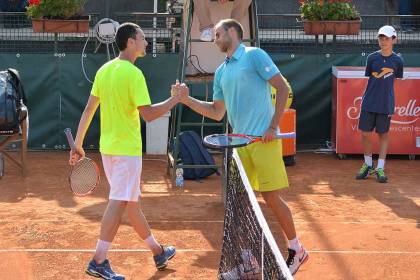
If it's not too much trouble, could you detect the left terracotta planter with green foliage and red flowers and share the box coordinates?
[26,0,90,33]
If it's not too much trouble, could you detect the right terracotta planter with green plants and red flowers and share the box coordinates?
[300,0,362,35]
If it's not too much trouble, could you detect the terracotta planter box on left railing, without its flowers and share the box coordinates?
[32,17,90,33]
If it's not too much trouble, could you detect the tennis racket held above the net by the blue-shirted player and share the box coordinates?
[204,132,296,149]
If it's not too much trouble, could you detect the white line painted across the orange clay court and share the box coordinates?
[0,249,420,255]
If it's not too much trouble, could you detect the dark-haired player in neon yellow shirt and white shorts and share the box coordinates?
[70,23,182,280]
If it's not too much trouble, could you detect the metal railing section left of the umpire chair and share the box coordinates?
[0,12,181,54]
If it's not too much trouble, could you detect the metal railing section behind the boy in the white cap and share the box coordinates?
[258,14,420,53]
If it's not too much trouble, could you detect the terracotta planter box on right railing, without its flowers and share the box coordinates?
[303,19,362,35]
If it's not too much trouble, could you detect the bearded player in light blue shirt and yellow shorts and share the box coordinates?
[175,19,308,274]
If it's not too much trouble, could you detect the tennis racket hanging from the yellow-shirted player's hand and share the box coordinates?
[64,128,100,196]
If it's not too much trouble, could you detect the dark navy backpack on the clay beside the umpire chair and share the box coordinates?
[179,131,219,180]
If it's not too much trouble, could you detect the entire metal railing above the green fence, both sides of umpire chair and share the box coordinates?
[0,13,420,54]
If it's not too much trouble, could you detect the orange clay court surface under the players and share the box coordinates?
[0,152,420,280]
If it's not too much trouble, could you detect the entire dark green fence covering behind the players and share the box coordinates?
[0,50,420,150]
